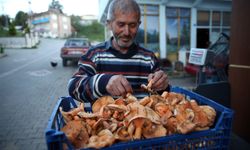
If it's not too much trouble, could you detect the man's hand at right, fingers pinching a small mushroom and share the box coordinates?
[148,70,168,91]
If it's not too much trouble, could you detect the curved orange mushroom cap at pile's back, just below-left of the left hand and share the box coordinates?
[92,96,115,113]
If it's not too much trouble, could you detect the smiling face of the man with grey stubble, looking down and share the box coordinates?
[109,12,140,50]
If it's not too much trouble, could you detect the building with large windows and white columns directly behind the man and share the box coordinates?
[99,0,232,61]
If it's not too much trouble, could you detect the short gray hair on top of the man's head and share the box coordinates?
[107,0,141,21]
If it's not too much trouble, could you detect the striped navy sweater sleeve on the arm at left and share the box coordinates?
[68,54,112,103]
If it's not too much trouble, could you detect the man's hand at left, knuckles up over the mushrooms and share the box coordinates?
[106,75,133,96]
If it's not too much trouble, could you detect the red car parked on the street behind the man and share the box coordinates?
[60,38,91,66]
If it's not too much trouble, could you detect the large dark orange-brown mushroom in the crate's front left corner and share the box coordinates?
[61,120,89,148]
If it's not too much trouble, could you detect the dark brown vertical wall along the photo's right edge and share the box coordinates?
[229,0,250,142]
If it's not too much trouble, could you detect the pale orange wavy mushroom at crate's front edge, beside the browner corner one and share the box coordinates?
[86,129,115,149]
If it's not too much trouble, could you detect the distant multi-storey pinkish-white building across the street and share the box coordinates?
[29,9,72,38]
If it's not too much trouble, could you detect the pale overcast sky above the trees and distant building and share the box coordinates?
[0,0,99,18]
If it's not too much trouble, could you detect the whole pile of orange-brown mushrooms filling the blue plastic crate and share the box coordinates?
[60,91,216,149]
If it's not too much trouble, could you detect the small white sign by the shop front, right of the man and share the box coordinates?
[188,48,207,65]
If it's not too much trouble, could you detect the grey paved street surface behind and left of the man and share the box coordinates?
[0,39,197,150]
